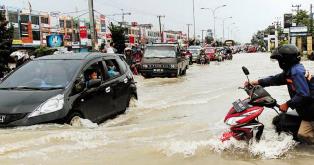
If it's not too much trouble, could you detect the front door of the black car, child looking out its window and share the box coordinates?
[78,59,113,122]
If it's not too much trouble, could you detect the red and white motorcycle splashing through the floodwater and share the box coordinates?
[220,67,301,142]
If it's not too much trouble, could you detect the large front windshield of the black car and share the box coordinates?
[0,60,81,90]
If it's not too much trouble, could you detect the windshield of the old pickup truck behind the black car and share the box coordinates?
[144,46,176,58]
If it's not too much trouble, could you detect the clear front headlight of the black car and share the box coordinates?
[28,94,64,118]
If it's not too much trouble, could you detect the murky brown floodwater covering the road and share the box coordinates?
[0,54,314,165]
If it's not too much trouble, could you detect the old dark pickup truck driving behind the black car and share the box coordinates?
[140,44,189,78]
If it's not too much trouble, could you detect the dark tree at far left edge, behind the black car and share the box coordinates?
[0,11,13,78]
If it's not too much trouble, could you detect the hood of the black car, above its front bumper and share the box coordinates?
[0,90,62,114]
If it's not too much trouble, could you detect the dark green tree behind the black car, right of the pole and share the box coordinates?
[109,23,126,54]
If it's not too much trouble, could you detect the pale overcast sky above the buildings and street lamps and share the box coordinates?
[0,0,314,42]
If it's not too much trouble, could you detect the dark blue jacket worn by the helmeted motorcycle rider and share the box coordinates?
[258,64,314,118]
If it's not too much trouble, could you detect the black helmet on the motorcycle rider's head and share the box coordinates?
[270,44,301,70]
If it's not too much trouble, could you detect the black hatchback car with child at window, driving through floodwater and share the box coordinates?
[0,53,137,127]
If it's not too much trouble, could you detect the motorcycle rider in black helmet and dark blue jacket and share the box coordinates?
[245,44,314,144]
